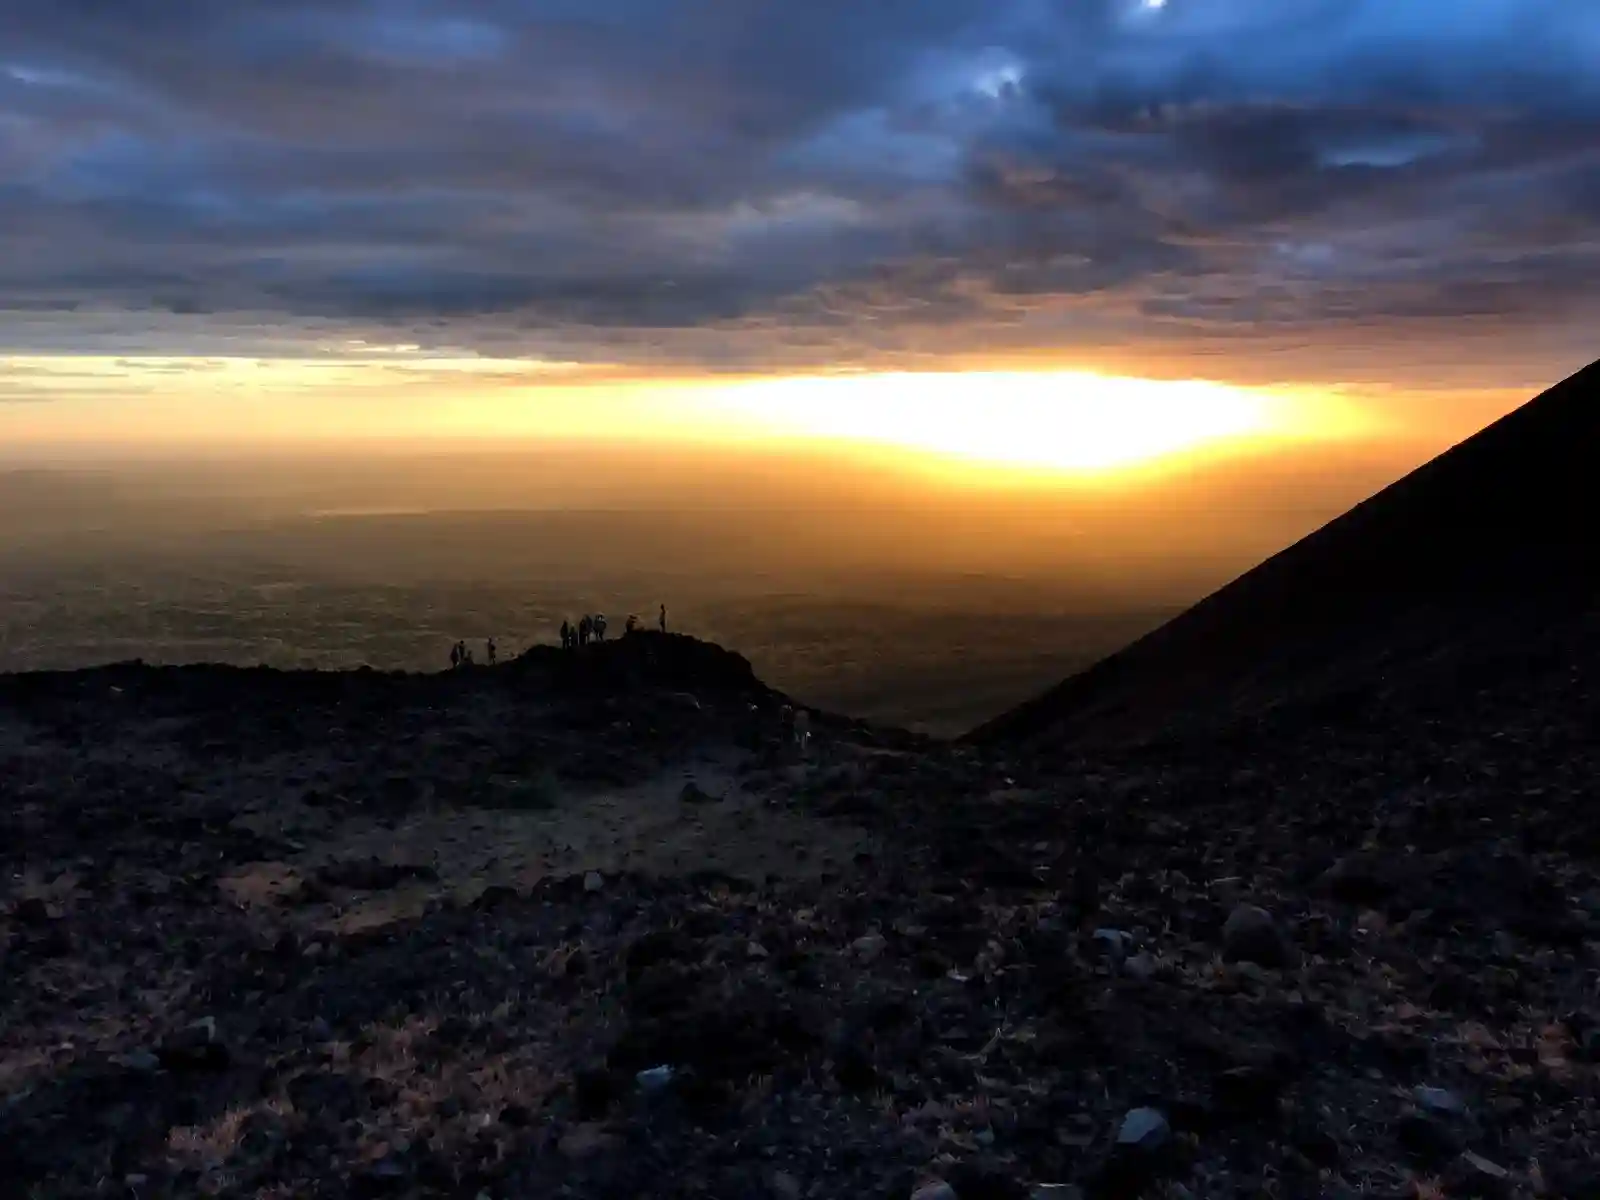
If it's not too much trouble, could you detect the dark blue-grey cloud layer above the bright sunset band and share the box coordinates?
[0,0,1600,376]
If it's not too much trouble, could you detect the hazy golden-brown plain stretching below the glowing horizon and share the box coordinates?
[0,448,1420,734]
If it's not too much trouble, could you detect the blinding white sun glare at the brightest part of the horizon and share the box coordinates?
[700,371,1337,472]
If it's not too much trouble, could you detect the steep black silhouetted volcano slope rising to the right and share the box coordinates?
[968,363,1600,742]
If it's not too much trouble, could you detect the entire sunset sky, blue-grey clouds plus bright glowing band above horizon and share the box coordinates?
[0,0,1600,470]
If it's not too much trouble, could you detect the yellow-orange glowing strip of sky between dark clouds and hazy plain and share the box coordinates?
[0,355,1517,482]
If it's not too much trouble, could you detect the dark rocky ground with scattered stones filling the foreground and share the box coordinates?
[0,635,1600,1200]
